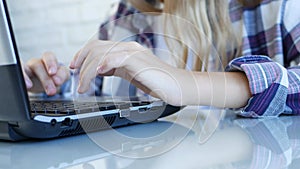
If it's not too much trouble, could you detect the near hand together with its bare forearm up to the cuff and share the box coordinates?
[70,41,251,108]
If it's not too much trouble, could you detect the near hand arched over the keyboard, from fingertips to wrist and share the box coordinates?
[70,40,185,104]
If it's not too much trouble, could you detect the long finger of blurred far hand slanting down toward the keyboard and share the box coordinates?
[29,59,57,95]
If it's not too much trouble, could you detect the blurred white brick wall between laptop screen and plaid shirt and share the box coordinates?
[8,0,119,64]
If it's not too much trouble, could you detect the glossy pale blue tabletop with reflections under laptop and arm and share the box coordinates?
[0,107,300,169]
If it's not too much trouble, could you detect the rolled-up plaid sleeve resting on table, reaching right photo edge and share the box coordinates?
[226,55,300,117]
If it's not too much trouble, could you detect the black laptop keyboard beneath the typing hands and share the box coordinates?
[30,101,151,116]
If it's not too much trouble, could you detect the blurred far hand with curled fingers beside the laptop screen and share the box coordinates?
[22,52,70,96]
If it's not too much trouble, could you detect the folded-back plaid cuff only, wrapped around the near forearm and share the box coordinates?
[226,55,289,117]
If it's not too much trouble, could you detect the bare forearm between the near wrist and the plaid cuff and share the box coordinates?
[179,71,251,108]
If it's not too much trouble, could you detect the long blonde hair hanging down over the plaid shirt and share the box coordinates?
[129,0,242,71]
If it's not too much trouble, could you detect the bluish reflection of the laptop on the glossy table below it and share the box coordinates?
[0,121,190,169]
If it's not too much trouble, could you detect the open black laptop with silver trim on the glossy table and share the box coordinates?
[0,0,180,141]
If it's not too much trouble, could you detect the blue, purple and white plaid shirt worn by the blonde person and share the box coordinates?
[99,0,300,117]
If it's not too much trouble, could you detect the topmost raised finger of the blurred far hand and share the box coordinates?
[42,52,59,75]
